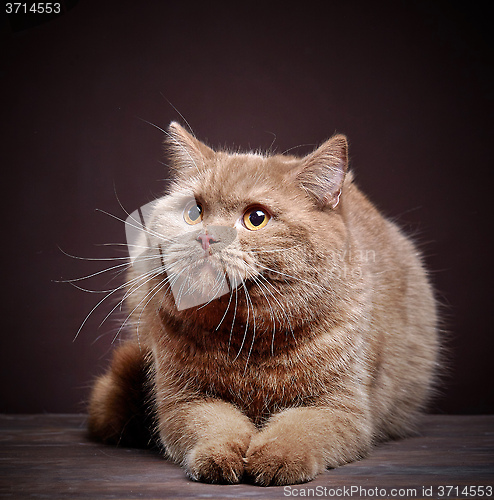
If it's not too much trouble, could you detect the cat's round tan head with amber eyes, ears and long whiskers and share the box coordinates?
[130,123,348,354]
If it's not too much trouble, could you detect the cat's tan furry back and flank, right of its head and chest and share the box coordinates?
[342,175,439,435]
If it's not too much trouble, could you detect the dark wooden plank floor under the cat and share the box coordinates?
[0,415,494,499]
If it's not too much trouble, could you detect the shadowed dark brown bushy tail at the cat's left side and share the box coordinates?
[88,341,153,446]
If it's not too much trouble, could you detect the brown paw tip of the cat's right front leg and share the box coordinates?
[245,432,325,486]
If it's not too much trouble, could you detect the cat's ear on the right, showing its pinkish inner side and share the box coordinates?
[297,134,348,208]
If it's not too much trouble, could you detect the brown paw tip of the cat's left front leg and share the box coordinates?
[185,439,248,484]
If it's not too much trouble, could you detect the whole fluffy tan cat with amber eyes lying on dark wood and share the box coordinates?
[88,122,439,486]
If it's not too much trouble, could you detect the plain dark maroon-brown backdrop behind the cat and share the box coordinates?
[0,0,494,413]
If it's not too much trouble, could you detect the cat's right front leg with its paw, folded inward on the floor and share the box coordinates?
[246,398,372,486]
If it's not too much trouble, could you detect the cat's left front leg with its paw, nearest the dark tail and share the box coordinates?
[158,397,257,483]
